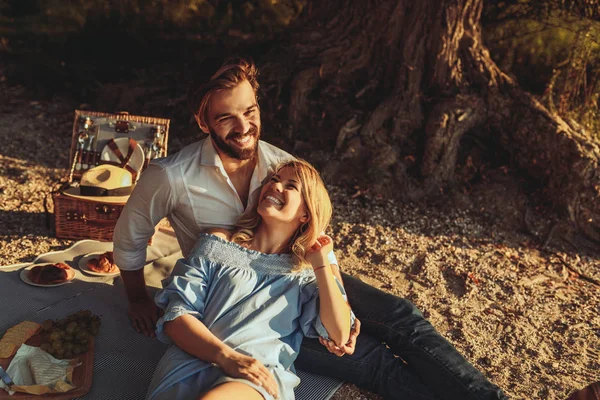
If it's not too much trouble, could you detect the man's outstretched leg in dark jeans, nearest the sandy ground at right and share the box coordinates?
[343,274,507,400]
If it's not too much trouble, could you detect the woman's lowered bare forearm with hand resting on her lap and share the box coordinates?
[164,314,278,397]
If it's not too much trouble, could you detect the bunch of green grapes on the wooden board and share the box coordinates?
[40,310,100,359]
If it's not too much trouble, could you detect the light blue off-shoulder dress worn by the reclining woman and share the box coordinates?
[147,234,354,400]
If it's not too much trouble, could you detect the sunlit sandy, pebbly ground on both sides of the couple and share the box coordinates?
[0,78,600,400]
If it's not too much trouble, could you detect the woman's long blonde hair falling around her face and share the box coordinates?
[231,159,332,271]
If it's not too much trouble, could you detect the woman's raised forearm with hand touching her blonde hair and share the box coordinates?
[306,235,351,346]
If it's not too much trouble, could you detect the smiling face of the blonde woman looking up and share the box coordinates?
[258,167,308,226]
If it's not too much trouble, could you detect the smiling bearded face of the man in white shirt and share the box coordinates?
[200,81,260,160]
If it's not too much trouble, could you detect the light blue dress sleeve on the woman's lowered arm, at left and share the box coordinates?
[154,257,212,343]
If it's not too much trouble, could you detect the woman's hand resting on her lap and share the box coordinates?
[216,350,279,398]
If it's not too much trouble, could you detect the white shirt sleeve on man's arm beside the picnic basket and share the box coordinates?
[113,163,175,271]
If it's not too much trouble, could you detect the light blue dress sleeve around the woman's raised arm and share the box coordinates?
[300,276,356,339]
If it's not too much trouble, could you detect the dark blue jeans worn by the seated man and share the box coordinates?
[295,274,507,400]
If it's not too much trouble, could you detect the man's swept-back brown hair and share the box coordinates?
[188,58,258,125]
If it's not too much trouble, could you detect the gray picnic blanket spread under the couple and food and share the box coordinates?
[0,231,342,400]
